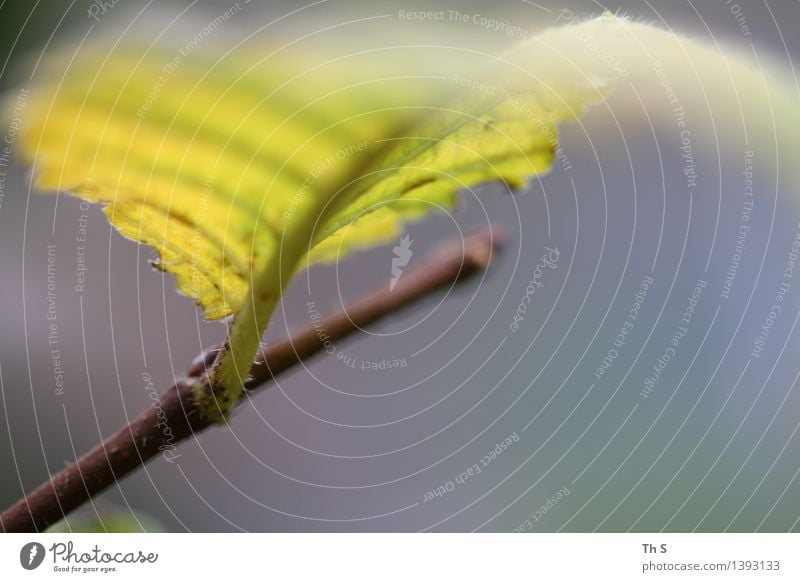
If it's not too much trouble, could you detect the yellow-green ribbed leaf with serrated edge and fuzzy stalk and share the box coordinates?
[22,18,732,416]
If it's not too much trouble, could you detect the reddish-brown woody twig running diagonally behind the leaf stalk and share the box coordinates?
[0,229,498,532]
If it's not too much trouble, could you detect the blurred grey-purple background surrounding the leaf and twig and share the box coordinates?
[0,0,800,531]
